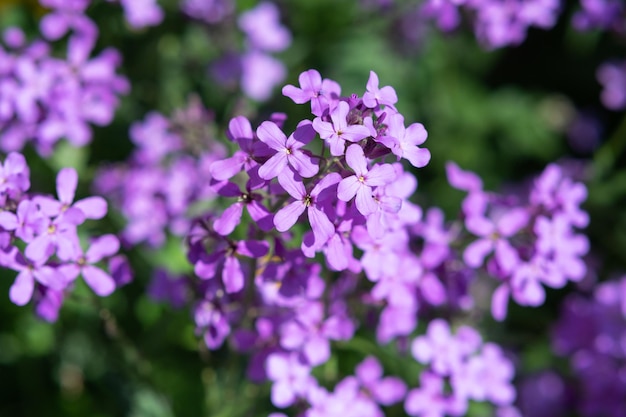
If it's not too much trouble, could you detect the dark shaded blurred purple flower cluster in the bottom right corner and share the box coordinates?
[552,277,626,417]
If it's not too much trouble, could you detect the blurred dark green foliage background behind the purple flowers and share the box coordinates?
[0,0,626,417]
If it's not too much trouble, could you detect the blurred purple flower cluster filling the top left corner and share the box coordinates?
[0,0,129,155]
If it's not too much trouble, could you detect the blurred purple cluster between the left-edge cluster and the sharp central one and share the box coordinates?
[94,96,225,247]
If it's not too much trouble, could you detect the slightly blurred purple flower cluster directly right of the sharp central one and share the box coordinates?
[447,163,589,320]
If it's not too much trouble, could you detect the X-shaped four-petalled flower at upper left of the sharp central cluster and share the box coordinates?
[257,122,319,180]
